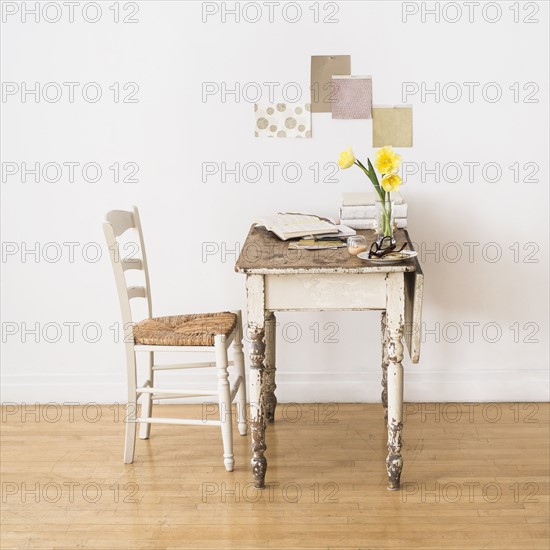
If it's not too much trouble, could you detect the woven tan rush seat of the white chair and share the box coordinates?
[134,311,237,346]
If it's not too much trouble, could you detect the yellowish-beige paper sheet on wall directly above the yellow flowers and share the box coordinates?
[372,105,412,147]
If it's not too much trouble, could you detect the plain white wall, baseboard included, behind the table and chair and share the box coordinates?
[1,1,549,402]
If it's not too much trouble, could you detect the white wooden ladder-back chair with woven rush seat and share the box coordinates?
[103,206,247,472]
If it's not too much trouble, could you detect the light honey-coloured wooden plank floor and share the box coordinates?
[1,403,550,550]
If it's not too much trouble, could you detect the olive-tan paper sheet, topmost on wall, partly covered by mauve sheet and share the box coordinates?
[311,55,351,113]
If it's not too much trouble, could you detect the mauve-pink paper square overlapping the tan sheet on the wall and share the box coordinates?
[332,75,372,119]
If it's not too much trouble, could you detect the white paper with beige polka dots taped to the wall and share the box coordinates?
[254,103,311,138]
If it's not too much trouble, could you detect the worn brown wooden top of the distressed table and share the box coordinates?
[235,225,421,275]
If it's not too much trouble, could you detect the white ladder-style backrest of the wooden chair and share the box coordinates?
[103,206,152,334]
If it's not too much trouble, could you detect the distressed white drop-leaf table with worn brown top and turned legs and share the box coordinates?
[235,226,423,490]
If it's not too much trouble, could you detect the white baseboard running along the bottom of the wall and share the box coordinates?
[1,368,550,404]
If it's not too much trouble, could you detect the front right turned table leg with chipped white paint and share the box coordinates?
[386,273,405,491]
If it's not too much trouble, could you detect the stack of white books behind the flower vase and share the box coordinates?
[340,191,407,229]
